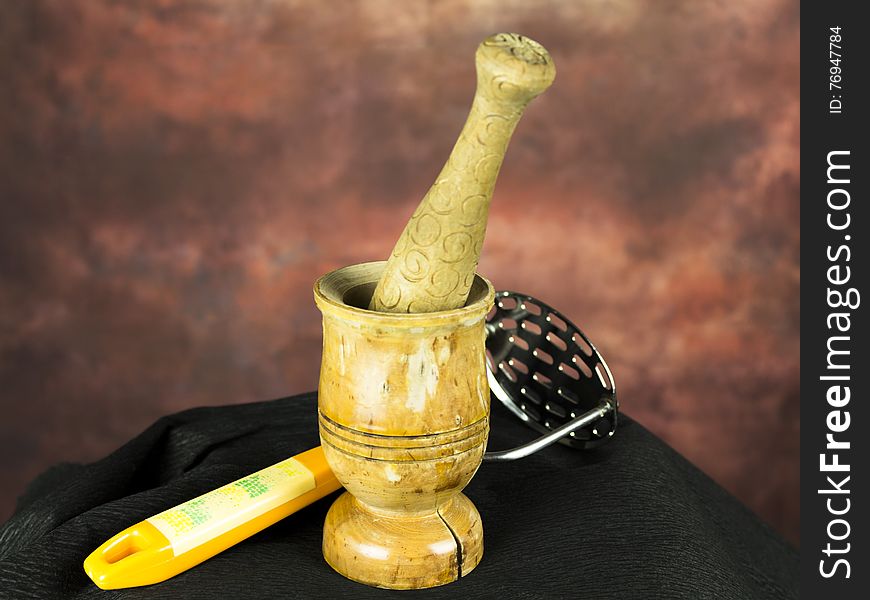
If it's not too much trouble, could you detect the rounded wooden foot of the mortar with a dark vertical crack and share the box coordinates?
[323,492,483,590]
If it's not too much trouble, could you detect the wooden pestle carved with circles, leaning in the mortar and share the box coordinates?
[369,33,556,313]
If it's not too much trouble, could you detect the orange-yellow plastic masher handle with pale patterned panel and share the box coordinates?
[84,446,341,590]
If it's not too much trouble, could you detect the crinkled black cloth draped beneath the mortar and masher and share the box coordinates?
[0,394,799,600]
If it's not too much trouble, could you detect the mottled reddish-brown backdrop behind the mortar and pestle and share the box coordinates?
[0,0,800,542]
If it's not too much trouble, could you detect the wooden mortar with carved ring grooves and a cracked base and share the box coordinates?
[314,262,495,589]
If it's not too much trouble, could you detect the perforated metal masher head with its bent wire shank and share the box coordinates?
[484,291,619,461]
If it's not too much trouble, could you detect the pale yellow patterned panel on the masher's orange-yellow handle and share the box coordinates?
[146,458,317,556]
